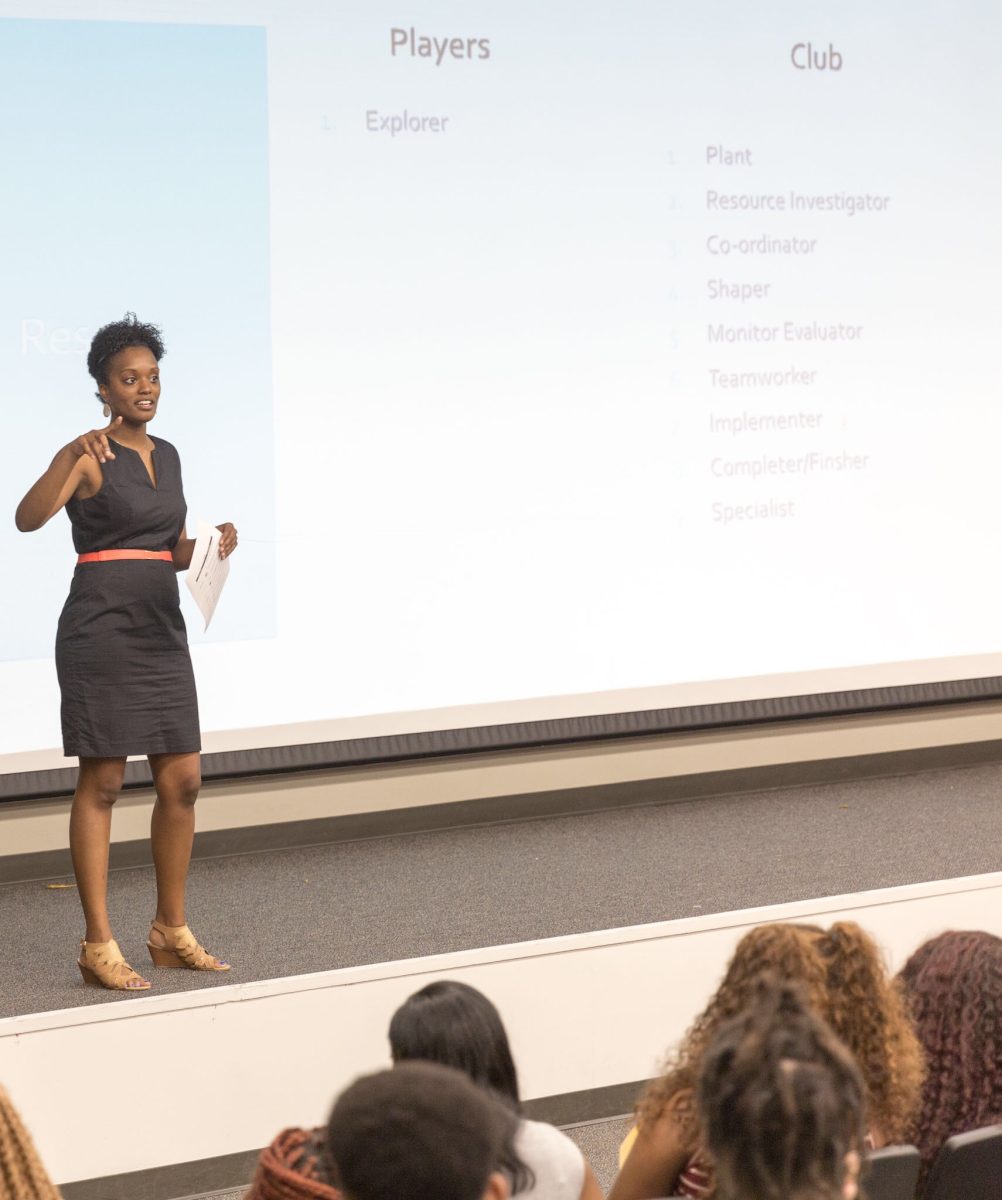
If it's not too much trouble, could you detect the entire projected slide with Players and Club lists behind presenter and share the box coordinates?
[0,0,1002,770]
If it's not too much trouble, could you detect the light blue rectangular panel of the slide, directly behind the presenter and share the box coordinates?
[0,10,276,660]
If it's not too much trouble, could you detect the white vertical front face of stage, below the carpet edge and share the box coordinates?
[7,874,1002,1183]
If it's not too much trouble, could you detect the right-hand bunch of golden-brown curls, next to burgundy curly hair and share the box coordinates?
[814,920,924,1141]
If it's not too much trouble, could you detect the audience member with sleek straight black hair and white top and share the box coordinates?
[390,980,602,1200]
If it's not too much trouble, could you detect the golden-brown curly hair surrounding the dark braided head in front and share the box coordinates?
[637,922,923,1145]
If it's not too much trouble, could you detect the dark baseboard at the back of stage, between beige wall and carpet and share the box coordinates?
[0,739,1002,884]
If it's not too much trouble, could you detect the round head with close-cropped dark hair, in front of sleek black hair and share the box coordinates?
[328,1062,515,1200]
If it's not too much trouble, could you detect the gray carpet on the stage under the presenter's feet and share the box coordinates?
[0,764,1002,1016]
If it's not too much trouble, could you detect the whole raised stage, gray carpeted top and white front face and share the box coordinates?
[0,766,1002,1200]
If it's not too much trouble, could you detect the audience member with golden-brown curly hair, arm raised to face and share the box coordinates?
[610,922,922,1200]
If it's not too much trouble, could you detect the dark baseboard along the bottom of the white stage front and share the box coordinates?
[60,1080,647,1200]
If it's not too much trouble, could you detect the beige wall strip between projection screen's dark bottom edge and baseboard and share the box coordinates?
[0,702,1002,878]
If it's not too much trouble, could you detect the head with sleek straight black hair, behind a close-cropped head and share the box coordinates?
[390,979,518,1110]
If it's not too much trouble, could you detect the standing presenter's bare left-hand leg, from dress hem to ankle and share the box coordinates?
[70,758,125,942]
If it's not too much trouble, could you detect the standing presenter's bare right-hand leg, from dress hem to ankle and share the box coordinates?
[150,752,202,926]
